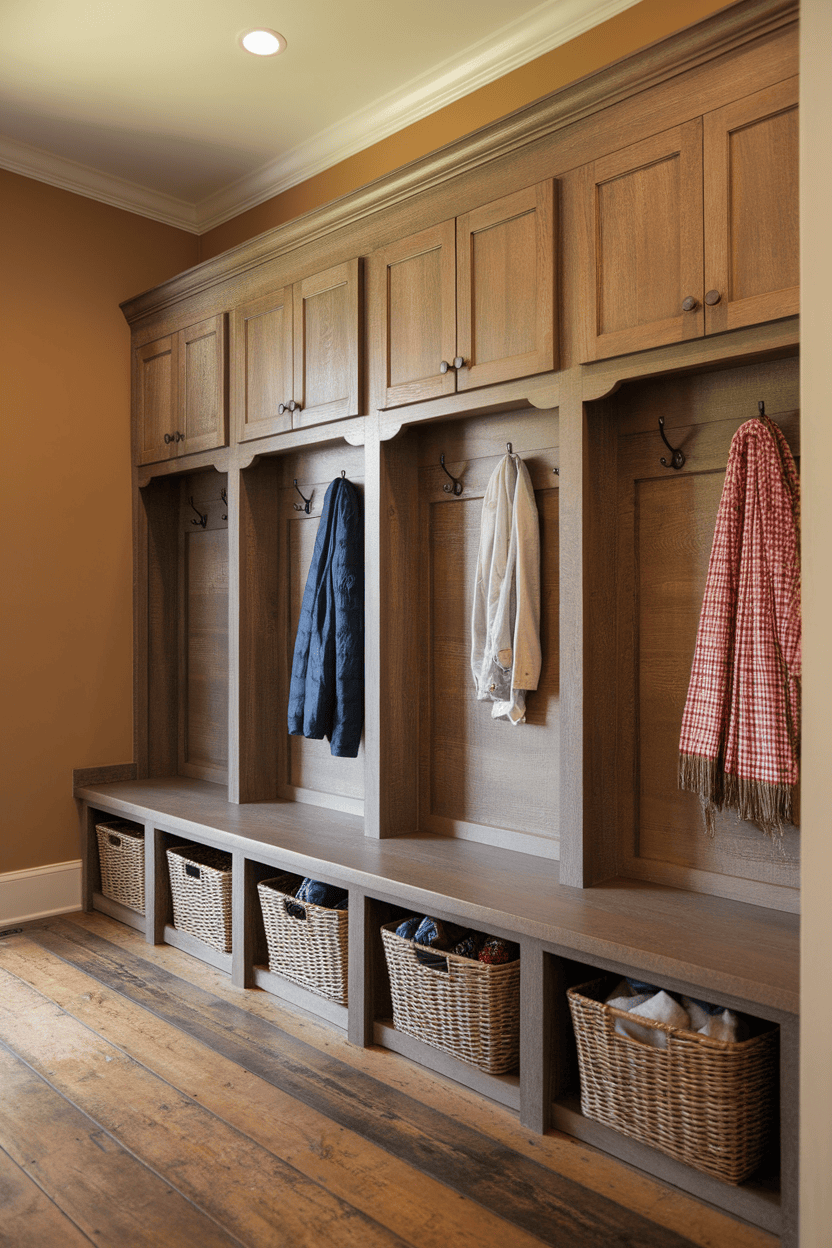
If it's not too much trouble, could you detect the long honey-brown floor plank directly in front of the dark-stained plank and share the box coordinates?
[1,937,548,1248]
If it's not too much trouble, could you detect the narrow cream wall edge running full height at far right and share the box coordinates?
[801,0,832,1248]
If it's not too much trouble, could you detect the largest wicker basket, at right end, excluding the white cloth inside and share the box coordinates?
[566,978,778,1183]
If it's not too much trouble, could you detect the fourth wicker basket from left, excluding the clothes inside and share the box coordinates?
[382,922,520,1075]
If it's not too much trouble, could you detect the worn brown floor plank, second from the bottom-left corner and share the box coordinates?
[0,1043,239,1248]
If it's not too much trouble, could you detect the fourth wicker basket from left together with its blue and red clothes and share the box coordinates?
[382,915,520,1075]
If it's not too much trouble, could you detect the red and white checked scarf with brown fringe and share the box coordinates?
[679,417,801,835]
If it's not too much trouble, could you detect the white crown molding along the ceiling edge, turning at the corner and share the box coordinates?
[0,0,637,235]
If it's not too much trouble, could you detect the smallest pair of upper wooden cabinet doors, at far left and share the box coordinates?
[133,312,228,464]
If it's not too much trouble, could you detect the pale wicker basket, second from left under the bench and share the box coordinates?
[167,845,231,953]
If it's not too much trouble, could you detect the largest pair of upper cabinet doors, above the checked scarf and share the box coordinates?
[583,79,798,361]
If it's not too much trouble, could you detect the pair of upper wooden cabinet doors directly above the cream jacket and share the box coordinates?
[372,180,555,407]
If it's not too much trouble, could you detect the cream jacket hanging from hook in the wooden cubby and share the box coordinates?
[472,454,540,724]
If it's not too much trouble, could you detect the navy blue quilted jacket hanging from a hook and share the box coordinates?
[288,477,364,759]
